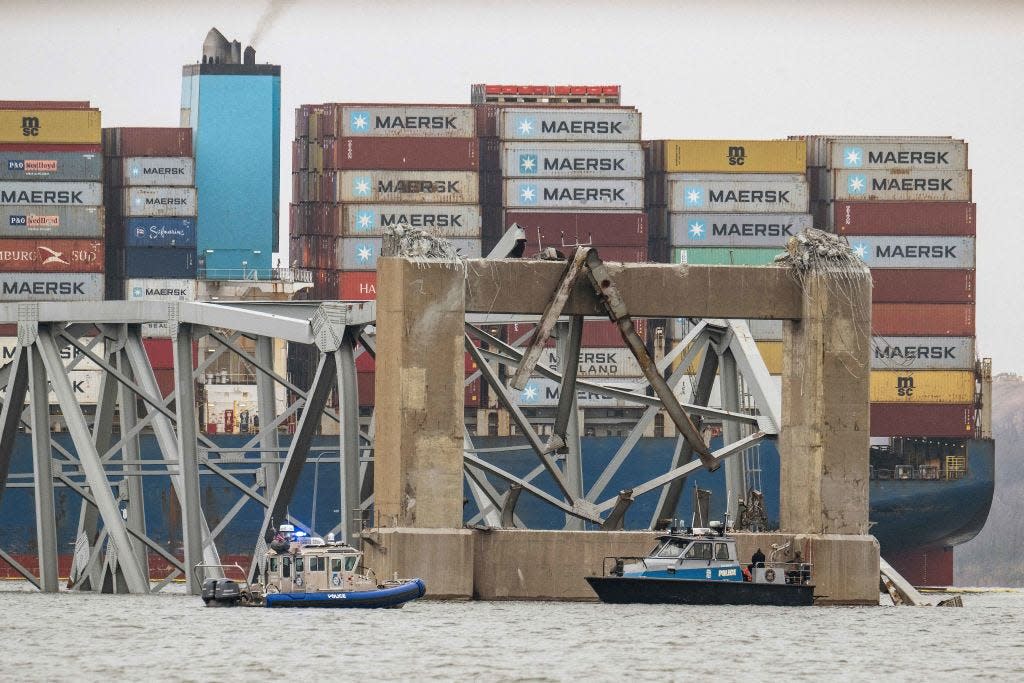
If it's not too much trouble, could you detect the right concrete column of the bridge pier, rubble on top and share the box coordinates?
[779,266,871,535]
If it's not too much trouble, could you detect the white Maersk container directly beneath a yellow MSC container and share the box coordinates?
[668,178,809,213]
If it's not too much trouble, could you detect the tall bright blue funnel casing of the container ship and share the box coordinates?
[181,63,281,279]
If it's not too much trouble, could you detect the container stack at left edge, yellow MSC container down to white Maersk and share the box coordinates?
[0,101,104,301]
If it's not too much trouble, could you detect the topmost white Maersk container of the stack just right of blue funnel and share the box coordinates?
[337,104,476,137]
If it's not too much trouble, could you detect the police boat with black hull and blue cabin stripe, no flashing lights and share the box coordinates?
[587,522,814,606]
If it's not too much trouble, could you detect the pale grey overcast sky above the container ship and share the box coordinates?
[8,0,1024,372]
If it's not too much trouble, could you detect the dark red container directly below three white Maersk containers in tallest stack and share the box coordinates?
[504,211,647,251]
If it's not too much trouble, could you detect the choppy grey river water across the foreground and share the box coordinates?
[0,584,1024,681]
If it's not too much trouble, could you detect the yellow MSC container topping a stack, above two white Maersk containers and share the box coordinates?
[665,140,807,173]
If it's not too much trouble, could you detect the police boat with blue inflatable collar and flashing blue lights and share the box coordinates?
[197,524,427,607]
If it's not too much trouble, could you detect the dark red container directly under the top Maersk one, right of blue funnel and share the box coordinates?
[323,136,479,171]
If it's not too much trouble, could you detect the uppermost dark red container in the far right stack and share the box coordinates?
[833,202,978,237]
